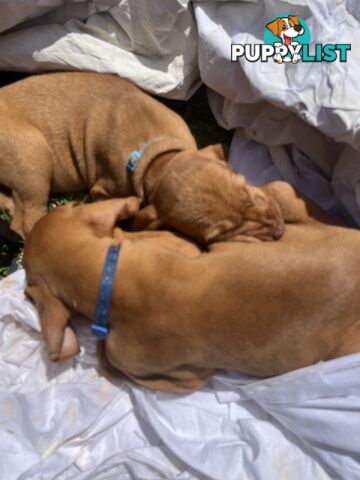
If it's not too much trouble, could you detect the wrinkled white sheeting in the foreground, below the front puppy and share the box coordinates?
[0,271,360,480]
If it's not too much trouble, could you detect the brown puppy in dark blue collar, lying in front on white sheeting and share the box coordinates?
[24,186,360,392]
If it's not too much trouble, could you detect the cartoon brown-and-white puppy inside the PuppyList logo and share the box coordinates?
[266,15,304,63]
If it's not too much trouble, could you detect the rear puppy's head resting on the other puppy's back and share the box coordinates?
[156,146,284,244]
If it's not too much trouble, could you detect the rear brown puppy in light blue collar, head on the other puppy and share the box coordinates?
[0,73,284,243]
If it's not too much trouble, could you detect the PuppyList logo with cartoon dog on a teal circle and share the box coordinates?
[231,15,351,64]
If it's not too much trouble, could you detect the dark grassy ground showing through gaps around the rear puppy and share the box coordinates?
[0,72,231,276]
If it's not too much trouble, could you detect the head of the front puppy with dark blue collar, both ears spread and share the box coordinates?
[24,197,139,361]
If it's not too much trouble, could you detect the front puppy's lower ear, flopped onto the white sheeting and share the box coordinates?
[25,285,79,362]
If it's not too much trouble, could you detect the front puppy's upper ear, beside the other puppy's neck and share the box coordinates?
[85,197,139,237]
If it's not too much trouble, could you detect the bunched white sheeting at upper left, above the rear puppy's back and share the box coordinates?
[0,0,200,99]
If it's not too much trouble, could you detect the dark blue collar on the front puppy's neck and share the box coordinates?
[91,245,121,339]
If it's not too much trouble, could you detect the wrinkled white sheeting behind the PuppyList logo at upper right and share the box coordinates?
[194,0,360,226]
